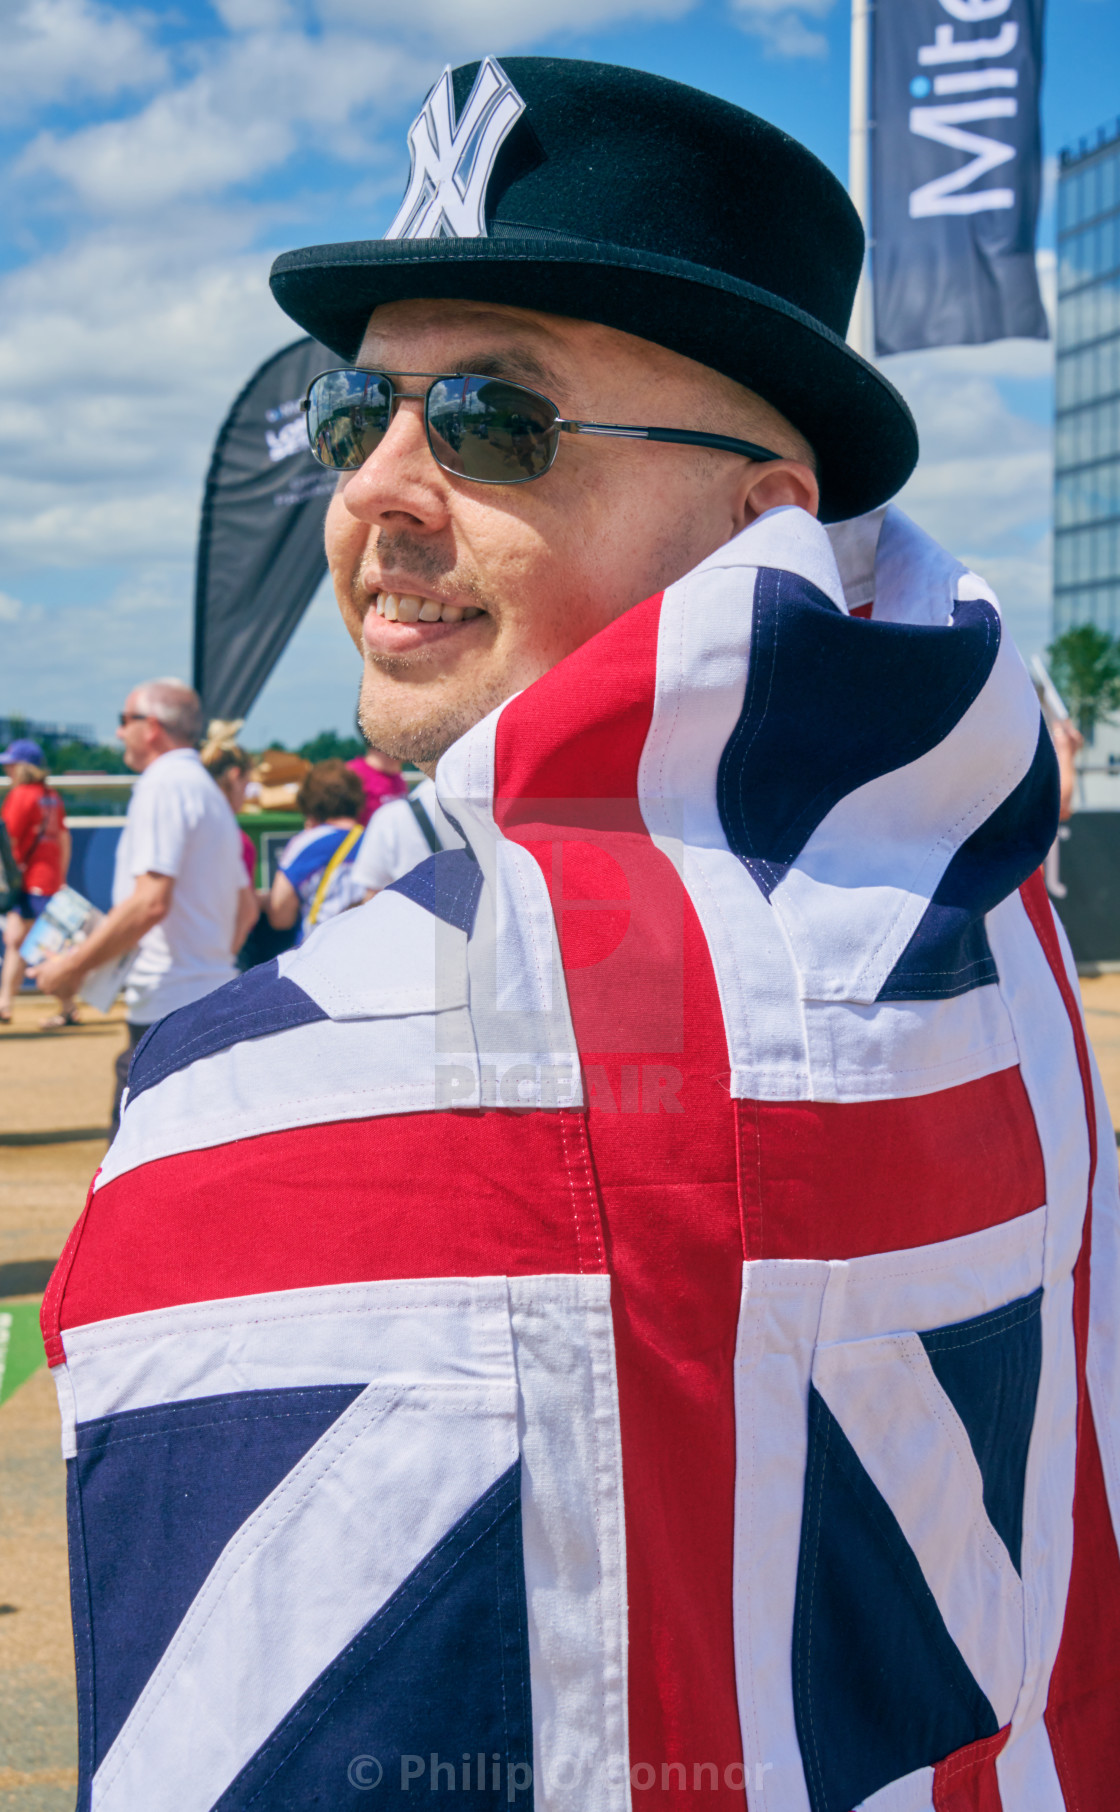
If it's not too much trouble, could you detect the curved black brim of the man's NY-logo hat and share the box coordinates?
[270,228,919,522]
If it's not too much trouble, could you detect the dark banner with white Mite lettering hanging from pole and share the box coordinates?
[872,0,1049,353]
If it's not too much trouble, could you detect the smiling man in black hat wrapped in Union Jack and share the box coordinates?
[43,58,1120,1812]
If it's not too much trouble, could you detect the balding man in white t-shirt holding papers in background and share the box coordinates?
[34,680,257,1125]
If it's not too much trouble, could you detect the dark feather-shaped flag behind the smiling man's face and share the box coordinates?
[194,339,339,718]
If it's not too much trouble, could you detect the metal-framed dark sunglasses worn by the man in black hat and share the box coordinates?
[301,370,783,484]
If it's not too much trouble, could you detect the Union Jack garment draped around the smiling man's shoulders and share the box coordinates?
[43,511,1120,1812]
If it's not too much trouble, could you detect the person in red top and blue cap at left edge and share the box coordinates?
[0,736,78,1027]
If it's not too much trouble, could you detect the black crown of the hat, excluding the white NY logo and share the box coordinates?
[427,56,863,337]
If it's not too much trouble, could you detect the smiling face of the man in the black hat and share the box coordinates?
[326,301,816,766]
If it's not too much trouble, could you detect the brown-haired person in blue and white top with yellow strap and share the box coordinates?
[265,761,364,944]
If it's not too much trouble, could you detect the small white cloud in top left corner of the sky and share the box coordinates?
[0,0,167,118]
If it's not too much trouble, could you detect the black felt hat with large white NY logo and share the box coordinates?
[272,56,917,522]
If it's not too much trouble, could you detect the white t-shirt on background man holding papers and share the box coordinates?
[112,748,245,1026]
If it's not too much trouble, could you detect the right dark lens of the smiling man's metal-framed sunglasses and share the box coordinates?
[428,377,560,484]
